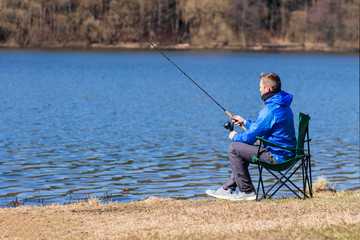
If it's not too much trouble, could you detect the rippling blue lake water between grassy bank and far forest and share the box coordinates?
[0,51,360,206]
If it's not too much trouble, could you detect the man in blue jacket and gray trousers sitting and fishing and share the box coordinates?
[206,73,296,200]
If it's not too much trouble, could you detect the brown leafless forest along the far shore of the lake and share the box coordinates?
[0,0,360,52]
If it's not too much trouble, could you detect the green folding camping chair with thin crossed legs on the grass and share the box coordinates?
[253,113,313,201]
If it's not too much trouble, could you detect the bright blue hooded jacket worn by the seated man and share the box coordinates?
[232,91,296,162]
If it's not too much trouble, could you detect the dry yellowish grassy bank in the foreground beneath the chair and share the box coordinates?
[0,191,360,239]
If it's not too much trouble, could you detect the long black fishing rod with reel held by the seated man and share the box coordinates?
[109,6,246,131]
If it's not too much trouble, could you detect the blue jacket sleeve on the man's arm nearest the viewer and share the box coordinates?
[232,107,274,144]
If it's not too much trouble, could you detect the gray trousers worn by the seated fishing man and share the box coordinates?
[223,142,277,192]
